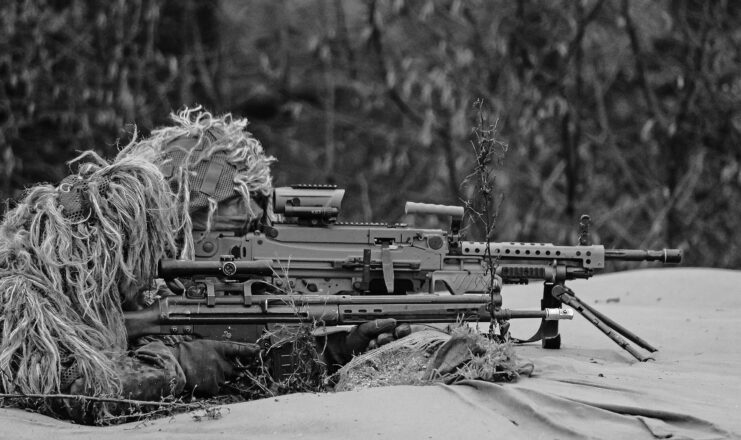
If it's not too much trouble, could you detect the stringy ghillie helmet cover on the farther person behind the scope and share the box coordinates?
[119,107,275,259]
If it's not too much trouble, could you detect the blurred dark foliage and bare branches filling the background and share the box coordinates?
[0,0,741,268]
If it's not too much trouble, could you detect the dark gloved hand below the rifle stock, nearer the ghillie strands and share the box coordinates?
[171,339,260,397]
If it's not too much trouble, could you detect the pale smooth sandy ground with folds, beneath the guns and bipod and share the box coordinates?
[0,268,741,440]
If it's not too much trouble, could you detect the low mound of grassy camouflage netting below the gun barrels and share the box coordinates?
[335,326,533,391]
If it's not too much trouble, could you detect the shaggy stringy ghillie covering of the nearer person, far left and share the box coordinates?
[0,153,178,395]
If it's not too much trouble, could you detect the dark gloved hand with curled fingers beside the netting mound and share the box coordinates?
[312,318,413,374]
